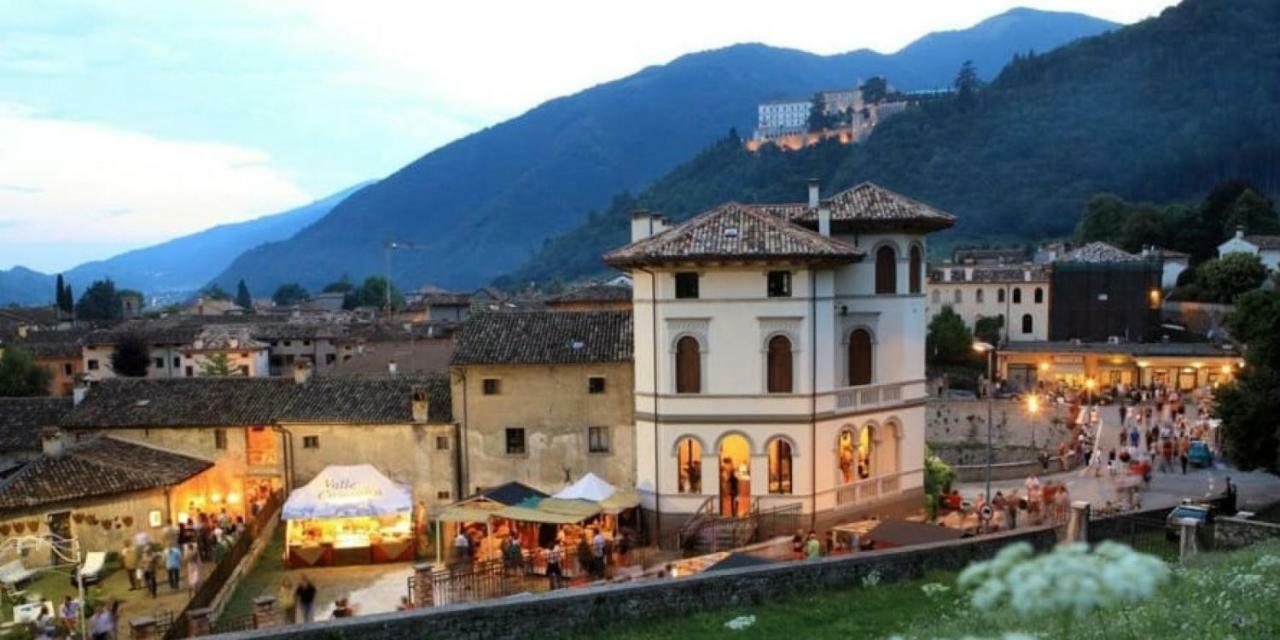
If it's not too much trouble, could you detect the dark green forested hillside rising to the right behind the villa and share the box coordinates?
[500,0,1280,285]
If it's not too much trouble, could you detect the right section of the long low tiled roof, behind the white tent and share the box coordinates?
[279,375,453,424]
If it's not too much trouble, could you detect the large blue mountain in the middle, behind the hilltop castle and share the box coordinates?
[207,10,1115,289]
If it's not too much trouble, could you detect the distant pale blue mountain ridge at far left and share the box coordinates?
[0,183,370,303]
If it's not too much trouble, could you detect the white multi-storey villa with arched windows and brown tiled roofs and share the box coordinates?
[605,180,955,535]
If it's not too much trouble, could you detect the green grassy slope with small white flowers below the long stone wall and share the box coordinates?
[568,541,1280,640]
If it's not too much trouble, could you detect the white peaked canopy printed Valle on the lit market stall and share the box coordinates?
[280,465,413,520]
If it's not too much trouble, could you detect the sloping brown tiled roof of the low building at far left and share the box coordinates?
[0,438,214,509]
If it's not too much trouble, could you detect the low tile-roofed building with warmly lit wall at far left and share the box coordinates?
[0,429,214,567]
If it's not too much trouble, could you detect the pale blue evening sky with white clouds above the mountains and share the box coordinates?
[0,0,1174,273]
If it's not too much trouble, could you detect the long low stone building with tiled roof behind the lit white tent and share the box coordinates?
[61,367,456,513]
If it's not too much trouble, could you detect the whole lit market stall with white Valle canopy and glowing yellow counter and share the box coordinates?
[280,465,413,567]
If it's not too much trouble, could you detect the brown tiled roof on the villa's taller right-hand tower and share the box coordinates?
[759,182,956,232]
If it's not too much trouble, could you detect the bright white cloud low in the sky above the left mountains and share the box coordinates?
[0,104,312,269]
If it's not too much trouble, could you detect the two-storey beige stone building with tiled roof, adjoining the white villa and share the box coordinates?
[451,311,636,493]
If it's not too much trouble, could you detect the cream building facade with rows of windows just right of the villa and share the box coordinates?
[928,264,1051,342]
